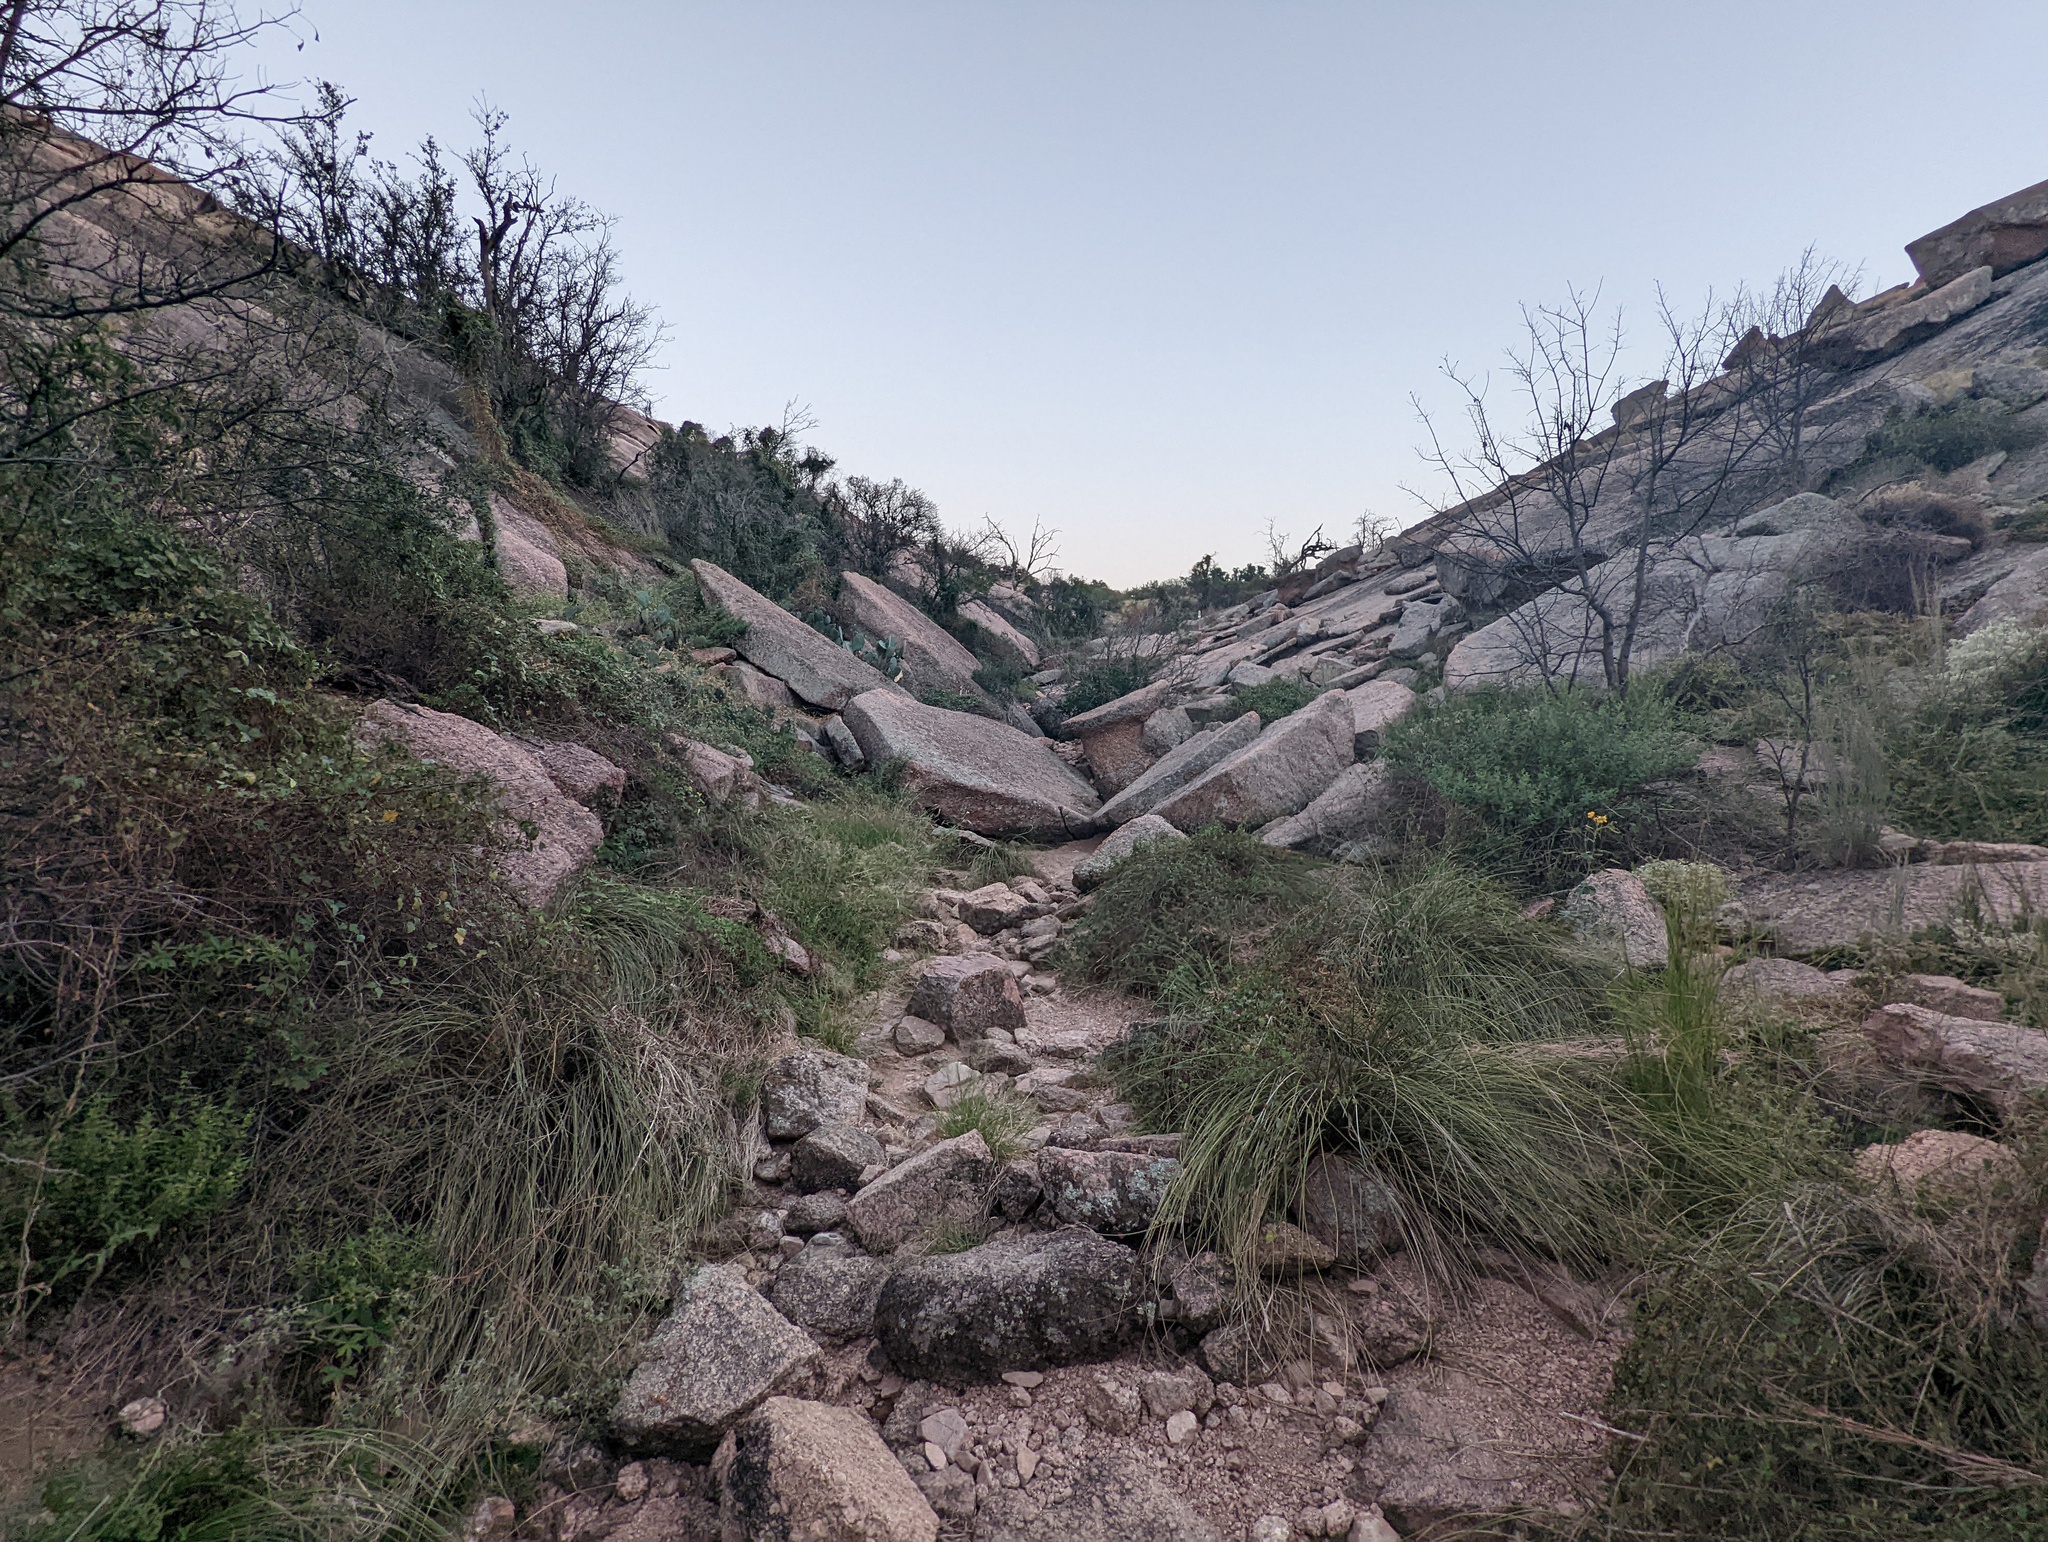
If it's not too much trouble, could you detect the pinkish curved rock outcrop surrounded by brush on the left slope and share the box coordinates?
[356,702,604,905]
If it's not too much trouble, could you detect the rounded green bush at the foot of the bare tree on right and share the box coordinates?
[1382,686,1698,866]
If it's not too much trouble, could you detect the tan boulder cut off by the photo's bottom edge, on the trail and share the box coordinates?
[719,1397,938,1542]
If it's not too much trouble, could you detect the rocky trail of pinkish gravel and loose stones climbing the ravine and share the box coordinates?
[487,842,1620,1542]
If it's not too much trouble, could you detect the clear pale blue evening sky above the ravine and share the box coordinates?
[251,0,2048,586]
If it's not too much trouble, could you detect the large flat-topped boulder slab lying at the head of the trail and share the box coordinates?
[842,690,1098,836]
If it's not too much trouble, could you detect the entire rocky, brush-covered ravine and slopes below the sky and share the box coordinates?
[12,41,2048,1542]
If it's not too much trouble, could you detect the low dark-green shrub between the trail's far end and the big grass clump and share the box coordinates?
[1061,827,1319,991]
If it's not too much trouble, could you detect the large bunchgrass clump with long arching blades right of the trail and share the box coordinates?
[1108,866,1618,1268]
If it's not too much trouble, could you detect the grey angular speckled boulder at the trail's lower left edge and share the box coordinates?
[612,1263,819,1460]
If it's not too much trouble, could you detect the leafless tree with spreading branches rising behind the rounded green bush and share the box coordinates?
[1423,291,1753,692]
